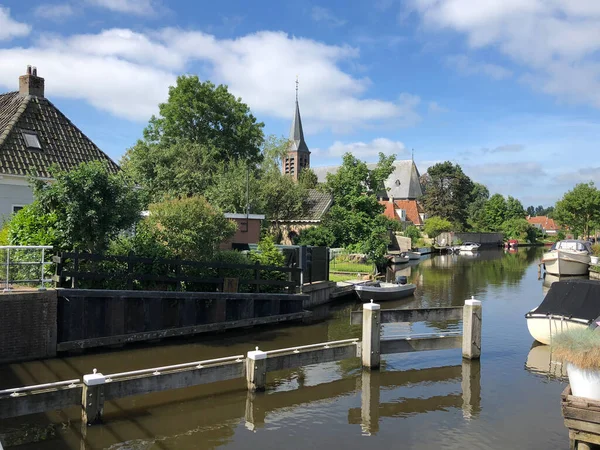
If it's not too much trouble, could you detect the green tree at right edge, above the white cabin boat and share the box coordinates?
[554,182,600,237]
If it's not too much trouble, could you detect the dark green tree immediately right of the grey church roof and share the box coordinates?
[423,161,473,229]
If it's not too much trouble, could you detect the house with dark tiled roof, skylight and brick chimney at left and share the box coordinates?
[0,66,119,223]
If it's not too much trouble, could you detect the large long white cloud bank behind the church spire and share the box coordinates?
[0,28,420,127]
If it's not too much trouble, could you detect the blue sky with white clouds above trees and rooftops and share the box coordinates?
[0,0,600,206]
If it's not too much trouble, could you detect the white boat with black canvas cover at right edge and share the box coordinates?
[525,280,600,345]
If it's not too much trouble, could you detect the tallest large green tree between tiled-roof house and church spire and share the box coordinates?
[121,76,264,201]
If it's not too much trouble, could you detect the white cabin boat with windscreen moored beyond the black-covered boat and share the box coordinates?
[542,239,592,276]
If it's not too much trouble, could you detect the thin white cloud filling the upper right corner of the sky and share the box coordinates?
[411,0,600,107]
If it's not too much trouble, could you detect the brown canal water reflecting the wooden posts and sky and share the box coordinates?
[0,248,568,450]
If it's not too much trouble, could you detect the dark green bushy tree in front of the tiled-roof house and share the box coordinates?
[31,161,141,252]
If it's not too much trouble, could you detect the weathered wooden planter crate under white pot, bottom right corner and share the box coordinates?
[561,385,600,450]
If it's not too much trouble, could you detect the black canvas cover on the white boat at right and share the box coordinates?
[533,280,600,322]
